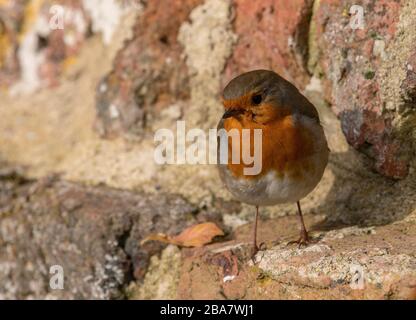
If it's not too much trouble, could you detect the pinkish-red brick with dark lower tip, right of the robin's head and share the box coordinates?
[313,0,412,178]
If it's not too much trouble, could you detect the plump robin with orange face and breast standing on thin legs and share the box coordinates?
[218,70,329,257]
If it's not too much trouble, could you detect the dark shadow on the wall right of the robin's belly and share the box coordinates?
[314,150,416,229]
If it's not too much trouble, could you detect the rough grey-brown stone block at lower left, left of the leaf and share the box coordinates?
[0,169,202,299]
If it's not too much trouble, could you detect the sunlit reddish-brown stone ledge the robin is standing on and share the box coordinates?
[178,217,416,299]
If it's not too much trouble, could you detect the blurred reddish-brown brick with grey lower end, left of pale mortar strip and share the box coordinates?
[97,0,202,137]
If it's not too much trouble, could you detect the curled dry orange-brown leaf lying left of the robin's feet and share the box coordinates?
[141,222,224,247]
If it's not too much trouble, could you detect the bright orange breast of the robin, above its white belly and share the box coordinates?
[224,115,314,179]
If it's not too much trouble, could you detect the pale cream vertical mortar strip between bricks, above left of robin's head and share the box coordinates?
[178,0,237,129]
